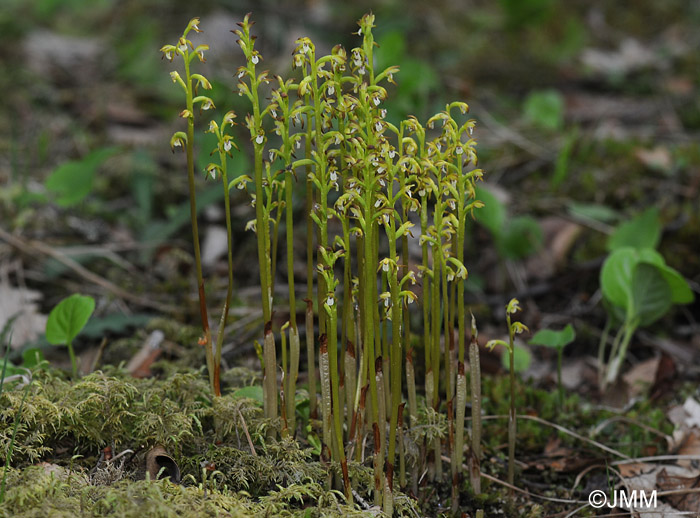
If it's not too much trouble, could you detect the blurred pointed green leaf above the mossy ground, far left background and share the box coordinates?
[46,148,117,207]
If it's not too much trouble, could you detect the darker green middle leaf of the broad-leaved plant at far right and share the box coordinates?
[631,262,672,326]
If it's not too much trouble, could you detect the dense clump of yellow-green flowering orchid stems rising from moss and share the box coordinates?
[162,14,492,515]
